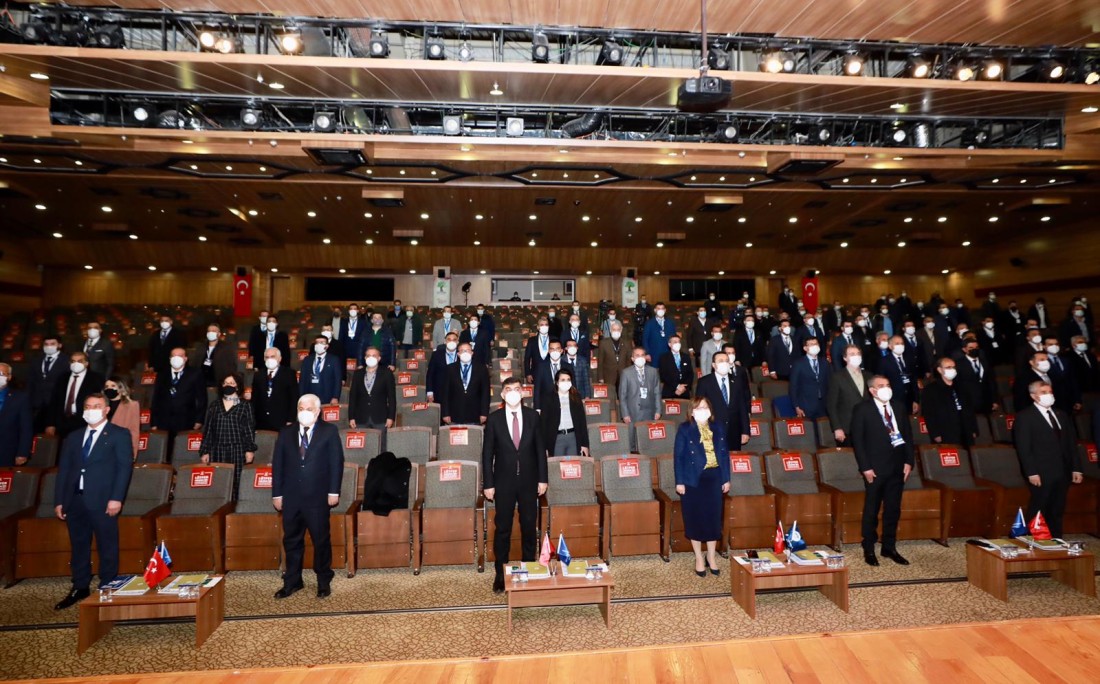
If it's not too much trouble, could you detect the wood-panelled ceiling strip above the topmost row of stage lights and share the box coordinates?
[54,0,1100,45]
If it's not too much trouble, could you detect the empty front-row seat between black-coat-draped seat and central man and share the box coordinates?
[413,461,485,574]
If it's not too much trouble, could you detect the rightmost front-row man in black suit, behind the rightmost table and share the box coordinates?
[1012,380,1085,537]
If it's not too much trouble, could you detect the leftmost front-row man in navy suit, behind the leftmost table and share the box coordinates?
[54,393,133,610]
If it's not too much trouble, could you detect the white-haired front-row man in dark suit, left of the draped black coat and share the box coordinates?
[272,394,343,598]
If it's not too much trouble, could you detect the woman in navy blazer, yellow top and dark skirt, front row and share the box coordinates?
[672,397,729,577]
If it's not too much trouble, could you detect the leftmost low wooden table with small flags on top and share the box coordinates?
[76,578,226,655]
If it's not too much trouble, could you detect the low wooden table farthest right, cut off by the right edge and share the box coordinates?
[966,539,1097,602]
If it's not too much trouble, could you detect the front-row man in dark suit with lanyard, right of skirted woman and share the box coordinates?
[850,375,915,565]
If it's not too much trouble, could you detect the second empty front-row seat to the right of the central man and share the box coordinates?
[596,454,661,562]
